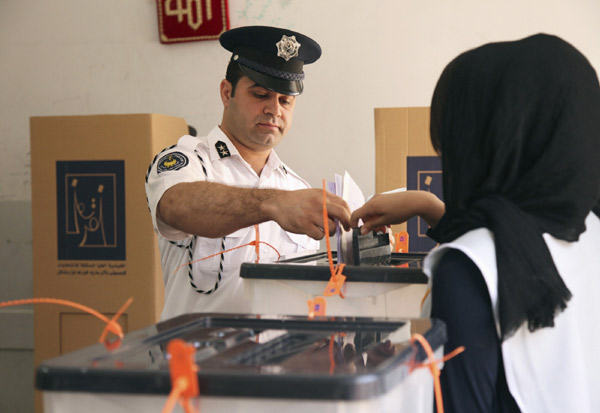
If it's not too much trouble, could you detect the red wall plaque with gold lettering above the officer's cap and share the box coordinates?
[156,0,229,43]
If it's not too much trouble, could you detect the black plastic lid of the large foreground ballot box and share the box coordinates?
[36,314,446,400]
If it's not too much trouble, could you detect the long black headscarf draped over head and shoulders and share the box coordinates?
[430,34,600,339]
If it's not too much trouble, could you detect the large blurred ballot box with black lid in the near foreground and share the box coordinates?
[36,314,446,413]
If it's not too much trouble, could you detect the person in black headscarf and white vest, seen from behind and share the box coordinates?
[352,34,600,412]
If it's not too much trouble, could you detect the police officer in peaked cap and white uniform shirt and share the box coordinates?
[146,26,350,319]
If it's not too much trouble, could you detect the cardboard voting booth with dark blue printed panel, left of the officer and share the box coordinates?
[30,114,188,411]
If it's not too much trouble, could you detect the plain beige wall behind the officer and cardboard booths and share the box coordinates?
[0,0,600,411]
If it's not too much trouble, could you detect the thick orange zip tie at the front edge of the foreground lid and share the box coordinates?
[163,338,200,413]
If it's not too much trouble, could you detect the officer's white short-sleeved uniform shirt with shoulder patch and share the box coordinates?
[146,126,319,320]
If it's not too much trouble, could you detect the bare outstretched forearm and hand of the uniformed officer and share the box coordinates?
[157,182,350,240]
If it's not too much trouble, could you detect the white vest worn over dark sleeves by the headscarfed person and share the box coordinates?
[424,213,600,413]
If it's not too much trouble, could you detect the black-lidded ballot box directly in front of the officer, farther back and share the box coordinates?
[240,251,428,318]
